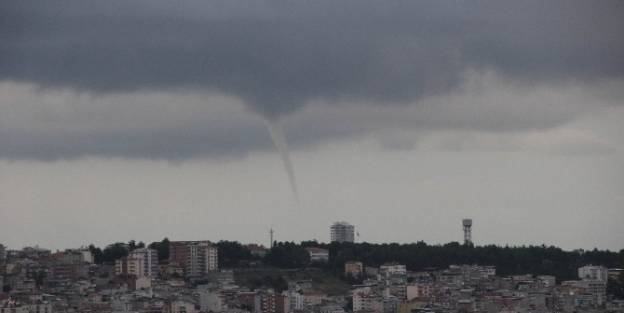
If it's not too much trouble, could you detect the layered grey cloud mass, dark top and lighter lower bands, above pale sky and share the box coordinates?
[0,0,624,159]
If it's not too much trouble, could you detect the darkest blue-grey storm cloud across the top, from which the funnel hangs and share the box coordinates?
[0,0,624,115]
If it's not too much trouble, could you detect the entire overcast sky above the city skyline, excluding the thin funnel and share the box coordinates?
[0,0,624,250]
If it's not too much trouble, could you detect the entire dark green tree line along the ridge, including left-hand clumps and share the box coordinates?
[89,238,624,280]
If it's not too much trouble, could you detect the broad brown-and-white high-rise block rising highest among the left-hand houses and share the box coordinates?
[169,241,219,276]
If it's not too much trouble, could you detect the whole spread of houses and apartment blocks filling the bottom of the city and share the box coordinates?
[0,241,624,313]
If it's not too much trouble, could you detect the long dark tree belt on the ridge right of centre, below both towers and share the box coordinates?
[320,241,624,280]
